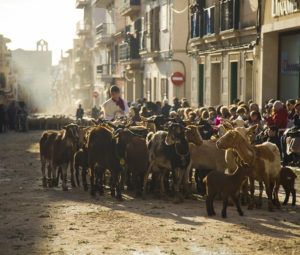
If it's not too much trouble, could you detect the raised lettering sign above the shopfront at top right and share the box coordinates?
[272,0,299,18]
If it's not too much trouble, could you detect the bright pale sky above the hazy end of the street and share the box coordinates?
[0,0,83,64]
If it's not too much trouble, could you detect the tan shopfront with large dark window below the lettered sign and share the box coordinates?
[258,0,300,104]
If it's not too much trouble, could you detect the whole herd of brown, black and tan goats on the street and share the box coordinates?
[40,116,296,217]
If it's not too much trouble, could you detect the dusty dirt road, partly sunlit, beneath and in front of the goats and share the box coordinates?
[0,132,300,255]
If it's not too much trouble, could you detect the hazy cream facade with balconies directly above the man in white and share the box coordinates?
[92,0,126,105]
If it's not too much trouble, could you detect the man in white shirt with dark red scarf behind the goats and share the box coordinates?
[102,85,129,120]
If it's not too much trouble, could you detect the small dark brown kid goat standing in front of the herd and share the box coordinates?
[203,163,250,218]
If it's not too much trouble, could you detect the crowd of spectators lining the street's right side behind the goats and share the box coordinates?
[122,98,300,165]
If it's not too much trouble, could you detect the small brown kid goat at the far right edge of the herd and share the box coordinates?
[274,167,297,206]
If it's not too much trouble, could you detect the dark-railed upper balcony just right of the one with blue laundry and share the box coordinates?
[220,0,240,32]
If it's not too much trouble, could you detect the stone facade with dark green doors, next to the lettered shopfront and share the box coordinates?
[188,0,260,106]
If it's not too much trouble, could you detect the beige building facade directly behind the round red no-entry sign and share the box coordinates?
[140,0,193,103]
